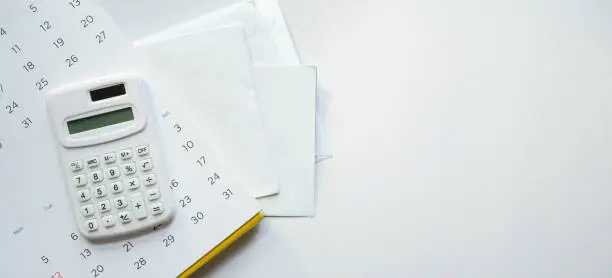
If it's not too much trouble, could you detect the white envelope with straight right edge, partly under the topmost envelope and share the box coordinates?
[253,66,317,216]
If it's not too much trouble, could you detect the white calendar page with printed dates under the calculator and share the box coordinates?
[0,0,259,278]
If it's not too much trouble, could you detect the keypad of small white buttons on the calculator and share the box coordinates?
[69,145,164,232]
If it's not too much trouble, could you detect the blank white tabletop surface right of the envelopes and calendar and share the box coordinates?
[103,0,612,278]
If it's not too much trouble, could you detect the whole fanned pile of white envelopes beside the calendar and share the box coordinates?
[103,0,326,216]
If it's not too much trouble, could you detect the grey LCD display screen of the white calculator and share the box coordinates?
[68,107,134,134]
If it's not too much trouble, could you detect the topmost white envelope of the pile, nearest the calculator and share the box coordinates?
[136,25,279,197]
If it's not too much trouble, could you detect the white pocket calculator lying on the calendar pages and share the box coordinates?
[46,75,173,240]
